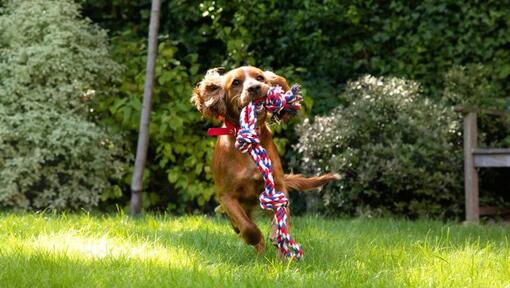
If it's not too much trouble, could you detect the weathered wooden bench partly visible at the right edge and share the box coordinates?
[457,108,510,223]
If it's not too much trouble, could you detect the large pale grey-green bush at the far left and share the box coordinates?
[0,0,125,209]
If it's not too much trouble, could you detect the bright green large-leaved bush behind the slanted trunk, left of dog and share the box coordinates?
[97,33,216,212]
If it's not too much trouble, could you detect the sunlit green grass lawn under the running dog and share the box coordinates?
[0,214,510,288]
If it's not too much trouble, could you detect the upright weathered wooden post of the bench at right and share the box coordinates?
[464,112,480,223]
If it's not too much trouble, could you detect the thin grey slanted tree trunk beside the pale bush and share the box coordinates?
[130,0,161,216]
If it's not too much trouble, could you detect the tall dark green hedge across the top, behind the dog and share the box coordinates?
[85,0,510,114]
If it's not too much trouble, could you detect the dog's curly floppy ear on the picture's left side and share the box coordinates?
[191,68,227,118]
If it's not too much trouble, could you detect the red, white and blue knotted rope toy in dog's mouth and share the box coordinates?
[236,85,303,259]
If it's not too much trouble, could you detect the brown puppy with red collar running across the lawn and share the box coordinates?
[192,66,337,253]
